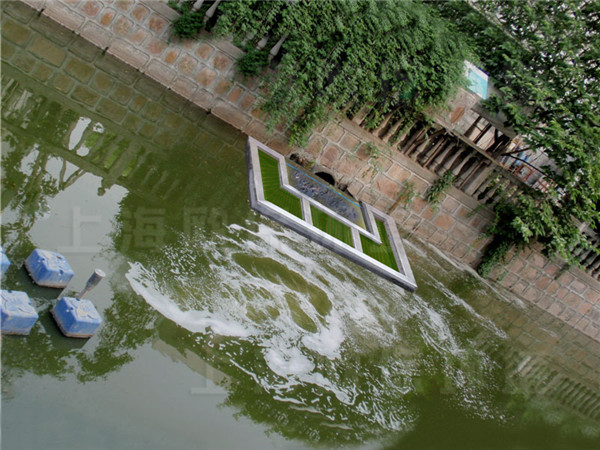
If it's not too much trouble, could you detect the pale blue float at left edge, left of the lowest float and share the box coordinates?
[0,289,39,335]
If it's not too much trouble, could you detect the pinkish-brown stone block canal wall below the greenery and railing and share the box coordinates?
[3,0,600,341]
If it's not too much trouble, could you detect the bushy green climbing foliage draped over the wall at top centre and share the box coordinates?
[173,0,468,145]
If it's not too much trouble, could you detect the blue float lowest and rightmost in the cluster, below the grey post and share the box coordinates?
[52,297,102,338]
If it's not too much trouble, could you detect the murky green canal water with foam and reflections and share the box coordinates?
[2,8,600,449]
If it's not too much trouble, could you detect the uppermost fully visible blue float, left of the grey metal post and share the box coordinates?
[25,248,75,288]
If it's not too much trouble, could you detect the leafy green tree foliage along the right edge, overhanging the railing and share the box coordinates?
[432,0,600,267]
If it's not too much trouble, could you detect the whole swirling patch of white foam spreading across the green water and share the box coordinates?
[127,222,508,430]
